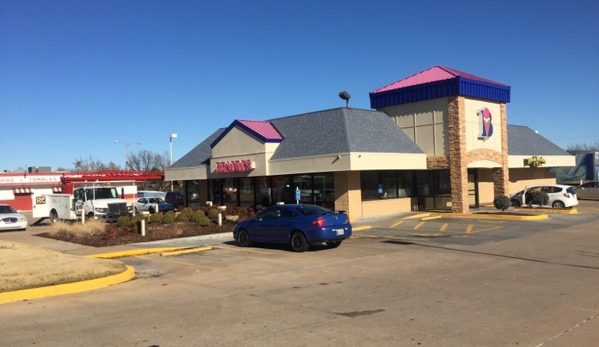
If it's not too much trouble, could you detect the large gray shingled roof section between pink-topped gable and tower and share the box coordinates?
[270,108,424,159]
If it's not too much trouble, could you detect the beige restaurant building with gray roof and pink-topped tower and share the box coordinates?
[165,66,574,218]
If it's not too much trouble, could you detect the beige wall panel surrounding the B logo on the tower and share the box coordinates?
[464,98,502,153]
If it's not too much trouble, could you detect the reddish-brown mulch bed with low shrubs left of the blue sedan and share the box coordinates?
[37,223,235,247]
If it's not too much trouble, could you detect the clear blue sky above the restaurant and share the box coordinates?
[0,0,599,170]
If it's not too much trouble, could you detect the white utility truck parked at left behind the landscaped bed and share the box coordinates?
[32,186,132,223]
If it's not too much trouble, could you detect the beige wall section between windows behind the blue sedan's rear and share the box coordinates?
[334,171,362,220]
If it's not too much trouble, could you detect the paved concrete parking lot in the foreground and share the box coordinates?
[0,201,599,347]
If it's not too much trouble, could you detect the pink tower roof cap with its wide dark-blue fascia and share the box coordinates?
[370,65,510,108]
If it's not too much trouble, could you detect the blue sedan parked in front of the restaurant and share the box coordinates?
[233,204,352,252]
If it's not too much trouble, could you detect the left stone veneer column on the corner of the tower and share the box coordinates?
[448,96,470,213]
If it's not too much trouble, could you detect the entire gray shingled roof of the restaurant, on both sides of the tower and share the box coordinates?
[170,113,570,168]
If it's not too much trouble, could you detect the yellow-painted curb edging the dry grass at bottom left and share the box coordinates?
[0,265,136,304]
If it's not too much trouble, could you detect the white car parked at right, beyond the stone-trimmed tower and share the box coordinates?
[510,184,578,208]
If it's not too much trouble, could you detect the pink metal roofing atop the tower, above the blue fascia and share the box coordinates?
[372,65,507,93]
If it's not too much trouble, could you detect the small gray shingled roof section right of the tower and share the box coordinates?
[507,124,571,155]
